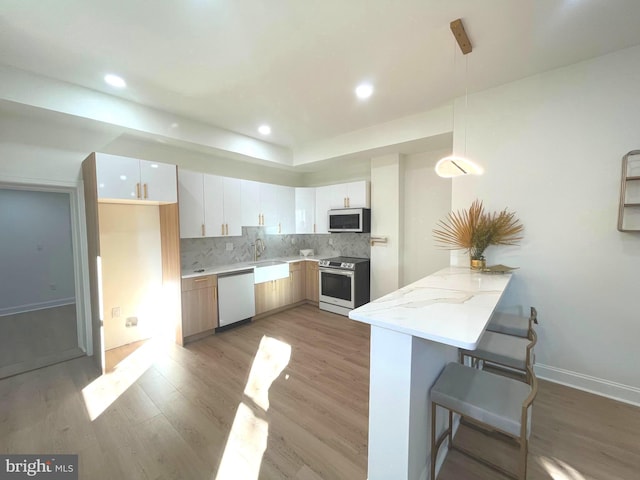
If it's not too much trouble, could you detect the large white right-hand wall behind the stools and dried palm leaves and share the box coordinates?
[452,47,640,403]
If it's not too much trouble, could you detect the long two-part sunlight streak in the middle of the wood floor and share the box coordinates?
[215,335,291,480]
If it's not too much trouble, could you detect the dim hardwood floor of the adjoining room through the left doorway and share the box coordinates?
[0,304,84,378]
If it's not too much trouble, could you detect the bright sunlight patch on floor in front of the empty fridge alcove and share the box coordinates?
[82,340,163,421]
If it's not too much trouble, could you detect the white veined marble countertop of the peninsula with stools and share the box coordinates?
[349,267,512,350]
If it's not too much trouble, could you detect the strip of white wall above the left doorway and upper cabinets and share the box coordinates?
[0,110,303,186]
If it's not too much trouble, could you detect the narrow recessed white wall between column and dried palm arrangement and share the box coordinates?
[401,149,451,286]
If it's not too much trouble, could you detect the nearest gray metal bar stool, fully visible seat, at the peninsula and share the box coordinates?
[431,362,538,480]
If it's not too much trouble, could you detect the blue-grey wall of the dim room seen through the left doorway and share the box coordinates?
[0,188,75,315]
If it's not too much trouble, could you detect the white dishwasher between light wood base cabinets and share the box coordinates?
[218,268,256,328]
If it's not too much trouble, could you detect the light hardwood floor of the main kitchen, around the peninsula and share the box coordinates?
[0,306,640,480]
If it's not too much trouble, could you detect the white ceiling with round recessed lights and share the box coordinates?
[0,0,640,160]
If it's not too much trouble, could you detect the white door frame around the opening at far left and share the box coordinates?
[0,175,94,356]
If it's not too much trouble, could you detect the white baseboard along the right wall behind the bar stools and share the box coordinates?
[535,363,640,406]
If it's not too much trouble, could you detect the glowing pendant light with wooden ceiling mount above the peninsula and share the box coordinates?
[435,18,483,178]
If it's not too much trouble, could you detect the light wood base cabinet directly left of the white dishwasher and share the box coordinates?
[182,275,218,338]
